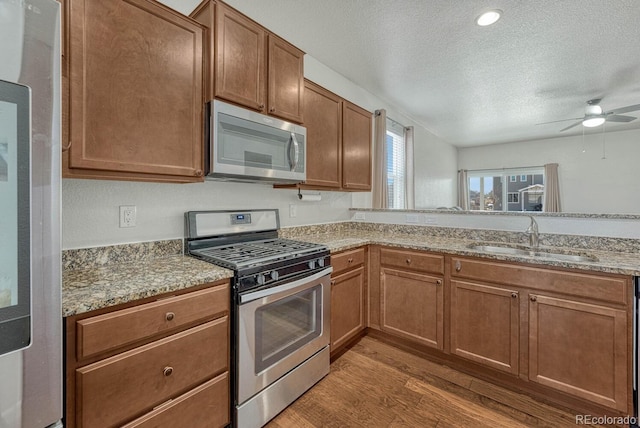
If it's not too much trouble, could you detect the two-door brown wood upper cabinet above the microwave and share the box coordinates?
[191,0,304,123]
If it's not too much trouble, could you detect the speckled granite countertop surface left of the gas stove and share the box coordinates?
[62,255,233,317]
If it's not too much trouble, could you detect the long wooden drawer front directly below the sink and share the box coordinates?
[450,257,630,304]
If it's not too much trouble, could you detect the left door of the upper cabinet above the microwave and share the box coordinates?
[214,3,267,113]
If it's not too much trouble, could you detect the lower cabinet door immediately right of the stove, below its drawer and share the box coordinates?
[331,267,365,351]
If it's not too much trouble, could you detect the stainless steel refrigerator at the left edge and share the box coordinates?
[0,0,62,428]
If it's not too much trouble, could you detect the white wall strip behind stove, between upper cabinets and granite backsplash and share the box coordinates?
[62,179,351,249]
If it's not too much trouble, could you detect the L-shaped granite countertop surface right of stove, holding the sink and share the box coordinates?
[296,231,640,276]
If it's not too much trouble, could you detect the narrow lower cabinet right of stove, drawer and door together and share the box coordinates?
[331,248,366,354]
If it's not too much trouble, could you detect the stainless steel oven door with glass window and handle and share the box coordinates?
[236,267,332,405]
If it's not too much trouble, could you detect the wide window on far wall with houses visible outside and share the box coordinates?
[467,167,544,211]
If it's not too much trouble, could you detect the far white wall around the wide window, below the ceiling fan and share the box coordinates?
[458,125,640,214]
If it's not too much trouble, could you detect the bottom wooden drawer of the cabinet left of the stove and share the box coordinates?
[123,372,229,428]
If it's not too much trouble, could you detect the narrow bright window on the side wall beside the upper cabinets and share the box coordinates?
[386,118,407,209]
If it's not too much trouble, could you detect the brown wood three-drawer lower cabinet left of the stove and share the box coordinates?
[65,282,230,428]
